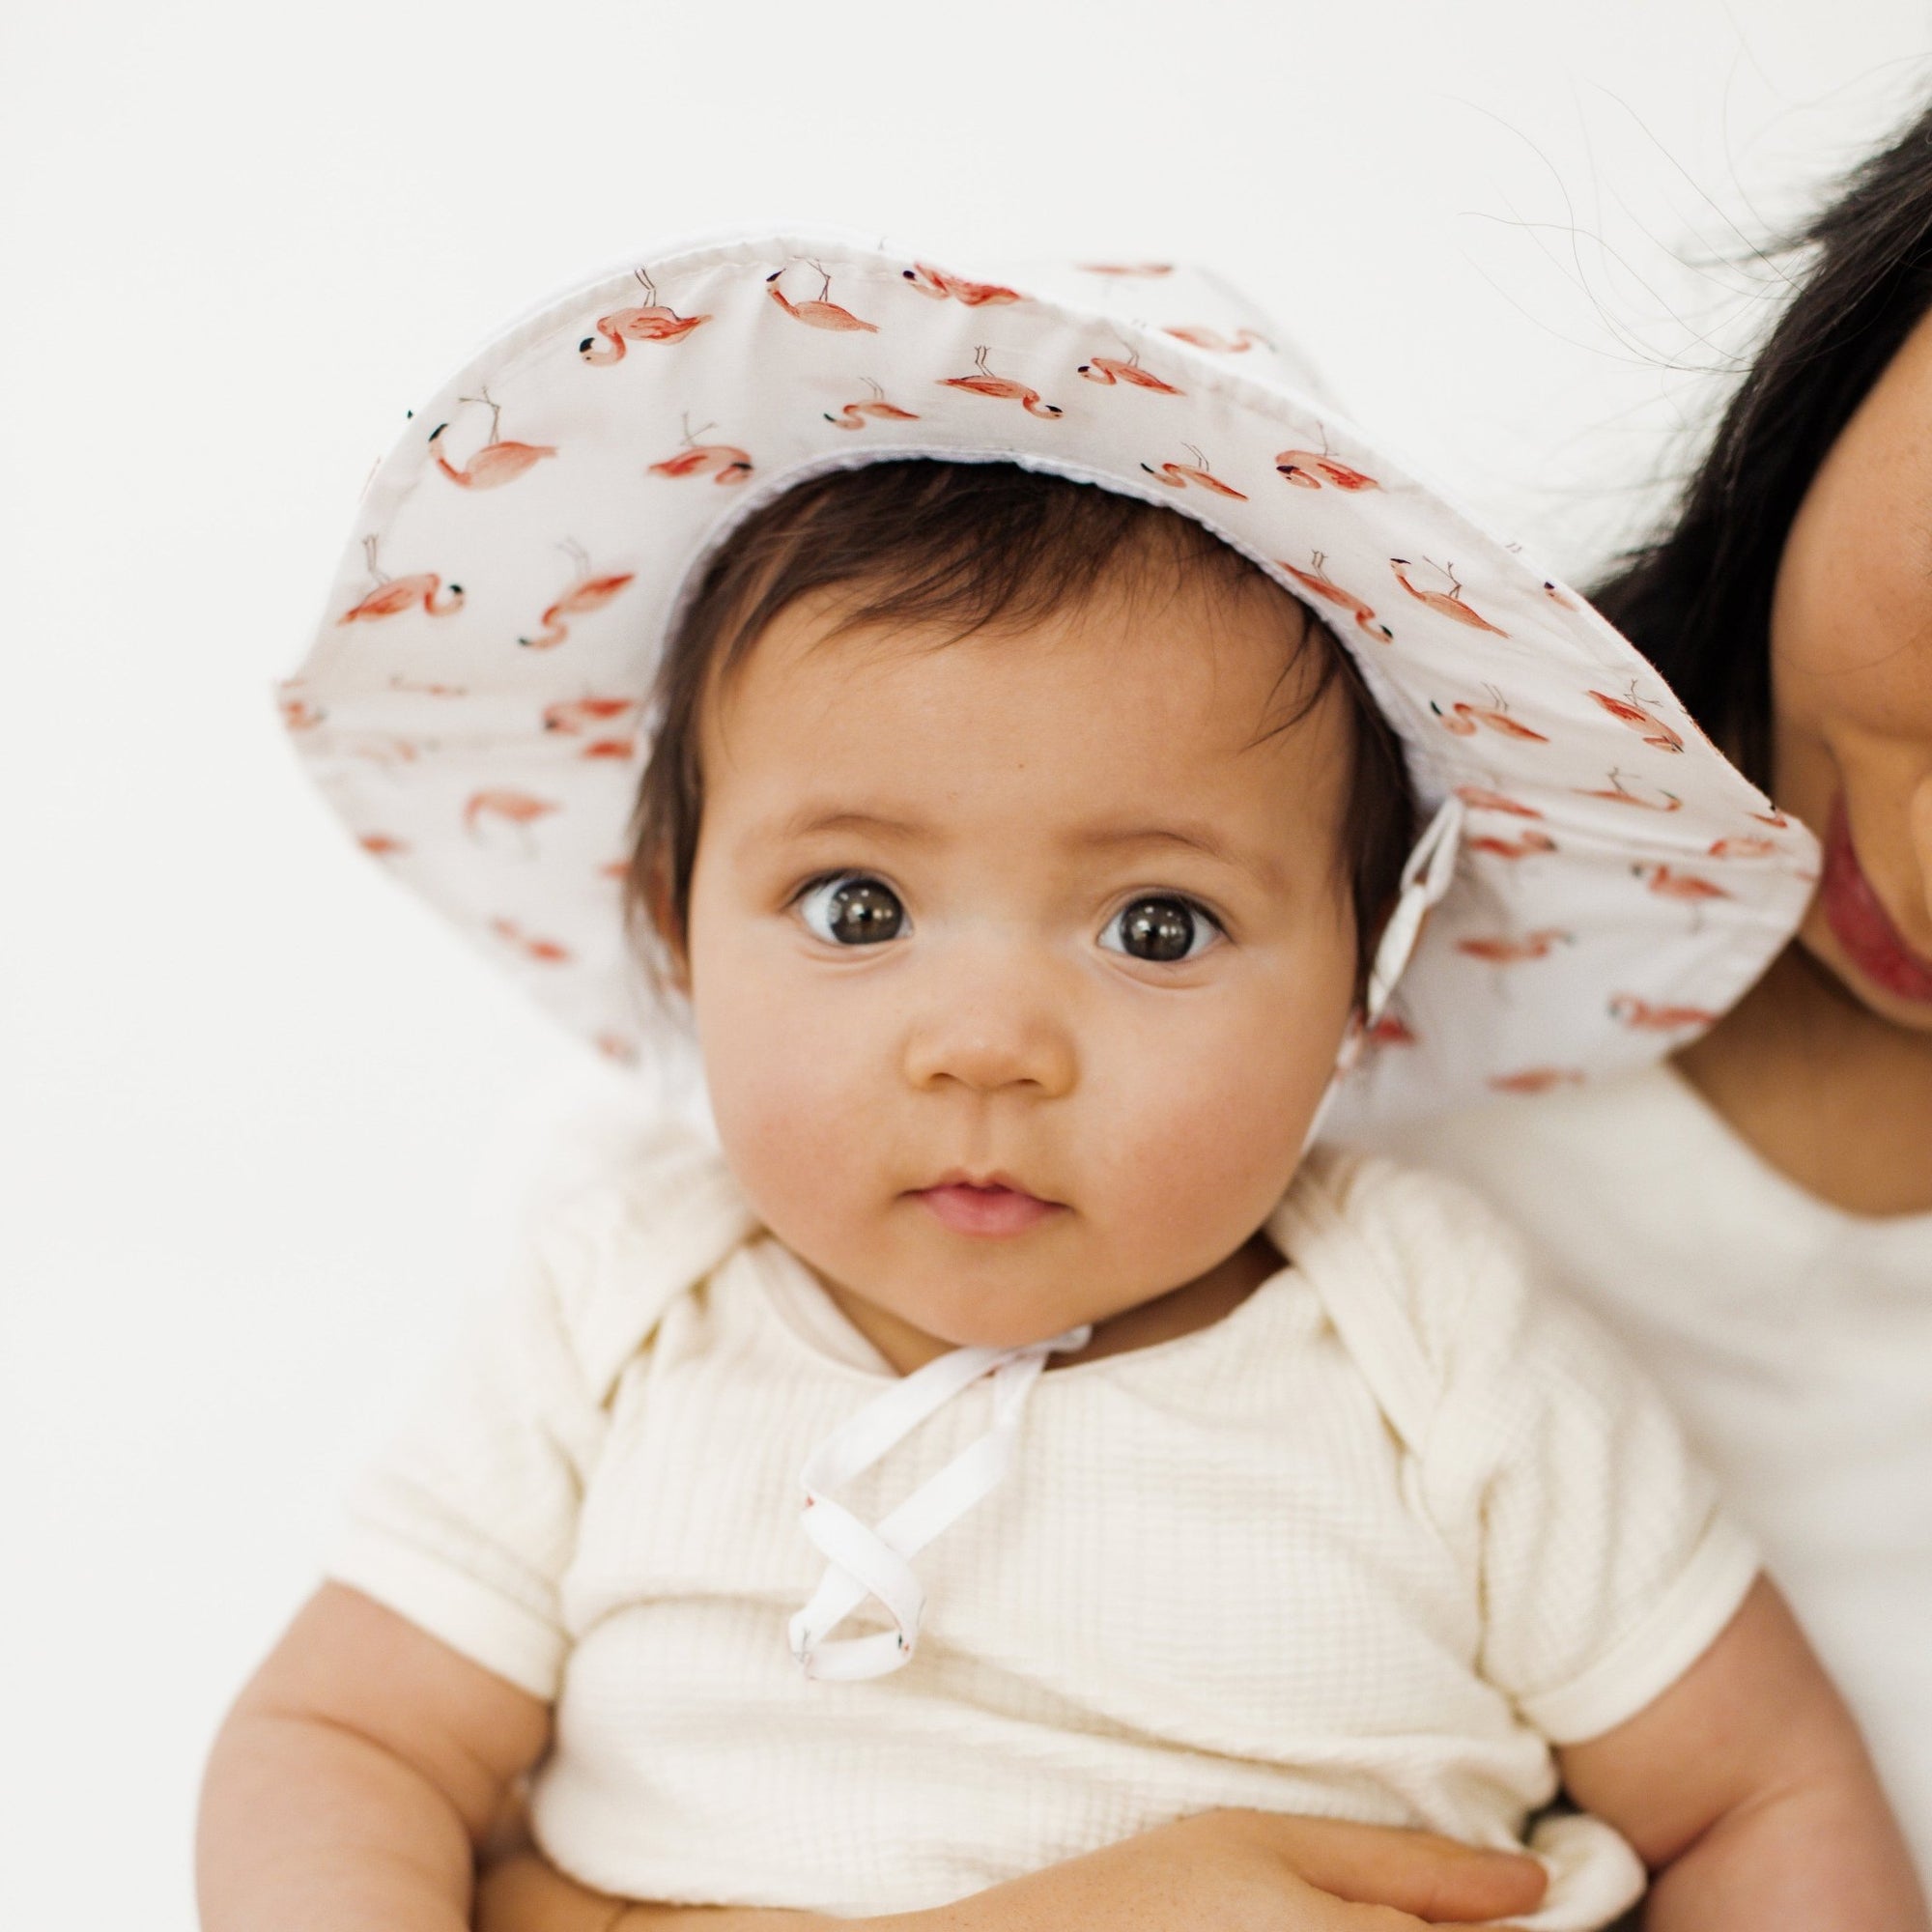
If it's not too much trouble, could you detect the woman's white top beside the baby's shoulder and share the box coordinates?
[1403,1068,1932,1886]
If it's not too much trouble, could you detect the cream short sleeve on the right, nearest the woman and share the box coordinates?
[1426,1190,1758,1745]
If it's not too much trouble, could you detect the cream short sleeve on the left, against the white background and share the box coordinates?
[325,1250,605,1702]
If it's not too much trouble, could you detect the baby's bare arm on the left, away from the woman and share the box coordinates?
[195,1584,551,1932]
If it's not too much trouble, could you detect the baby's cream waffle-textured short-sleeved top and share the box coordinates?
[332,1138,1756,1928]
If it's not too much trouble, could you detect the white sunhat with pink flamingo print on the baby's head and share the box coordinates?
[282,232,1816,1128]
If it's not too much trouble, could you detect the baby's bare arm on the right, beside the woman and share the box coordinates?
[1559,1577,1928,1932]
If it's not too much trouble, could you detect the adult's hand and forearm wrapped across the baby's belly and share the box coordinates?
[477,1810,1546,1932]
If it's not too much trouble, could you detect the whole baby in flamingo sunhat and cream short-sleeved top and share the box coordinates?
[201,238,1924,1932]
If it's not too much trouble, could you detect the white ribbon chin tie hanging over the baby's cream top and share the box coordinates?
[790,1327,1092,1683]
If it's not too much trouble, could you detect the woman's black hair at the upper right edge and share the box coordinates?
[1594,98,1932,788]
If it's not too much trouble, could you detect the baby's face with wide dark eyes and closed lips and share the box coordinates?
[688,576,1356,1347]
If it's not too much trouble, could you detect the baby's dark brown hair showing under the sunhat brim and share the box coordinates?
[624,458,1416,983]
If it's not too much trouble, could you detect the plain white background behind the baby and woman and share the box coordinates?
[0,0,1932,1932]
